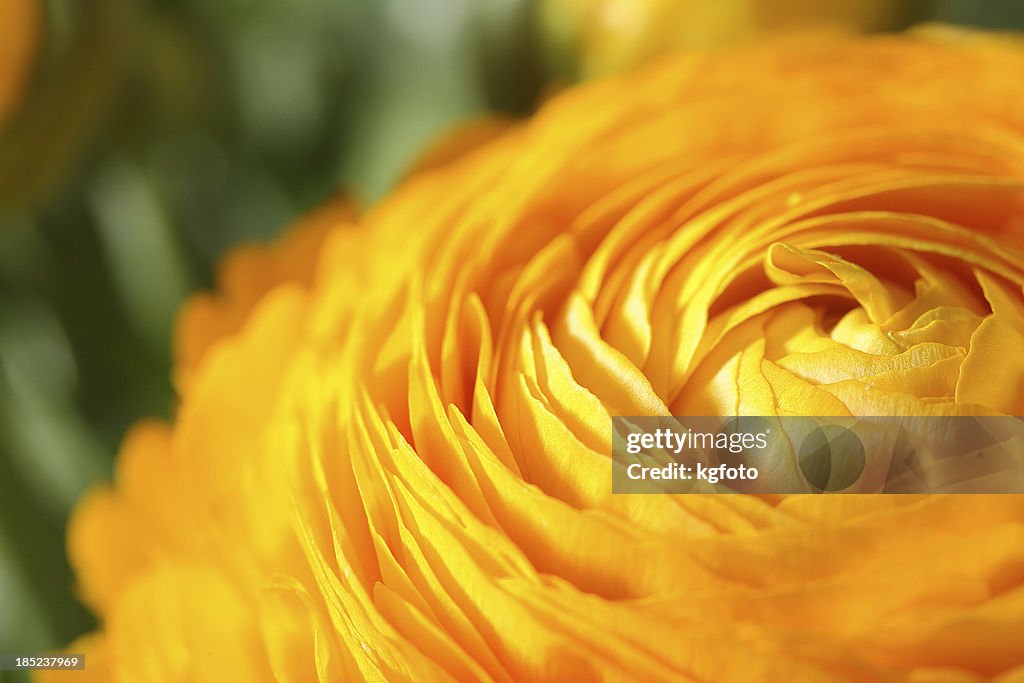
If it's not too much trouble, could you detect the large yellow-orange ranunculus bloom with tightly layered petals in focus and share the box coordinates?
[48,31,1024,683]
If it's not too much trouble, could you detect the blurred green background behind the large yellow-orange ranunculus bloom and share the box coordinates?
[0,0,1024,681]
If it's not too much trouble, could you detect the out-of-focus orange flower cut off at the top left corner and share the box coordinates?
[0,0,41,130]
